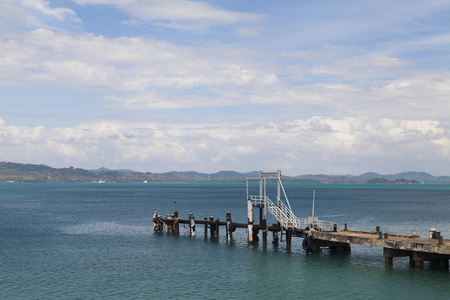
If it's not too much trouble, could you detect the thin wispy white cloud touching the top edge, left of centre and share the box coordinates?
[74,0,262,31]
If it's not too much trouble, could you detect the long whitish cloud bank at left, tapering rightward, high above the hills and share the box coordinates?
[0,29,270,91]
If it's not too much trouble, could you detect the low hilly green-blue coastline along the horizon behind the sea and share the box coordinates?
[0,161,450,184]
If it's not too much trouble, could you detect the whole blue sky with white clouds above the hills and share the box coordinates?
[0,0,450,176]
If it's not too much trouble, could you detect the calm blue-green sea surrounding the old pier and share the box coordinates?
[0,183,450,299]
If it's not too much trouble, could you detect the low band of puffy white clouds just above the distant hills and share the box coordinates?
[0,117,450,174]
